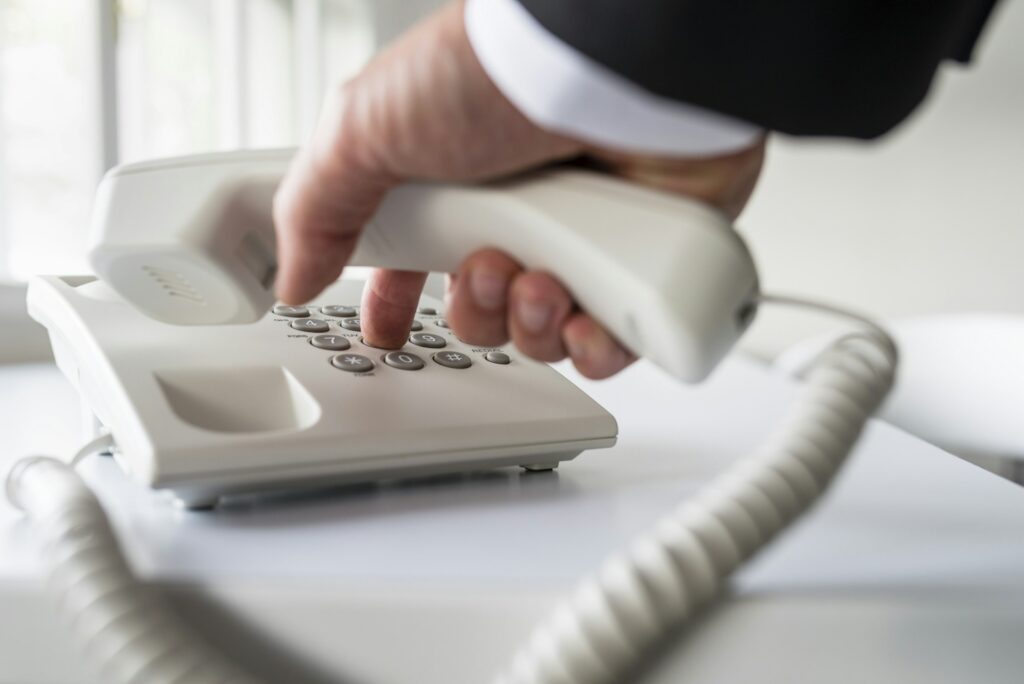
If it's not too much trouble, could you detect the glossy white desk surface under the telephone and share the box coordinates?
[0,359,1024,684]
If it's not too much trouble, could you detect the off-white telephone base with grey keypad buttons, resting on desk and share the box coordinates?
[29,276,617,510]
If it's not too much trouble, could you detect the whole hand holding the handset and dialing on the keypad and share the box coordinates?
[274,1,763,378]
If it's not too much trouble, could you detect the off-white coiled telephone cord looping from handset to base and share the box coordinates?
[7,296,897,684]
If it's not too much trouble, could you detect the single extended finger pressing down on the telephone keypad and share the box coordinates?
[359,269,427,349]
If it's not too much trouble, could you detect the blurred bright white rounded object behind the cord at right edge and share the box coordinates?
[775,313,1024,471]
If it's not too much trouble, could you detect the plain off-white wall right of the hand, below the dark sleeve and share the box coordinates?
[740,0,1024,354]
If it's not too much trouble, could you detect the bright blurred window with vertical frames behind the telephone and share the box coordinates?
[0,0,376,281]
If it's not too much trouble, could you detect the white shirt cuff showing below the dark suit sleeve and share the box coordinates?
[465,0,763,157]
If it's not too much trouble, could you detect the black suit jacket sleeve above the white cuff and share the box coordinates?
[519,0,997,138]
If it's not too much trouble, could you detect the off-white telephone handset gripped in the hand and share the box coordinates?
[90,149,758,382]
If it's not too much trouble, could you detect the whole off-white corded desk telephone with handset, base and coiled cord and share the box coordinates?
[7,151,896,684]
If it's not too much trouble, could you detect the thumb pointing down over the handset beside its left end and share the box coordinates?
[273,92,395,304]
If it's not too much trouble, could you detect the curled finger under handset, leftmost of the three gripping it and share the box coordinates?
[446,249,522,347]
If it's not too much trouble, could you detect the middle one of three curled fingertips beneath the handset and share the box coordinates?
[508,271,572,361]
